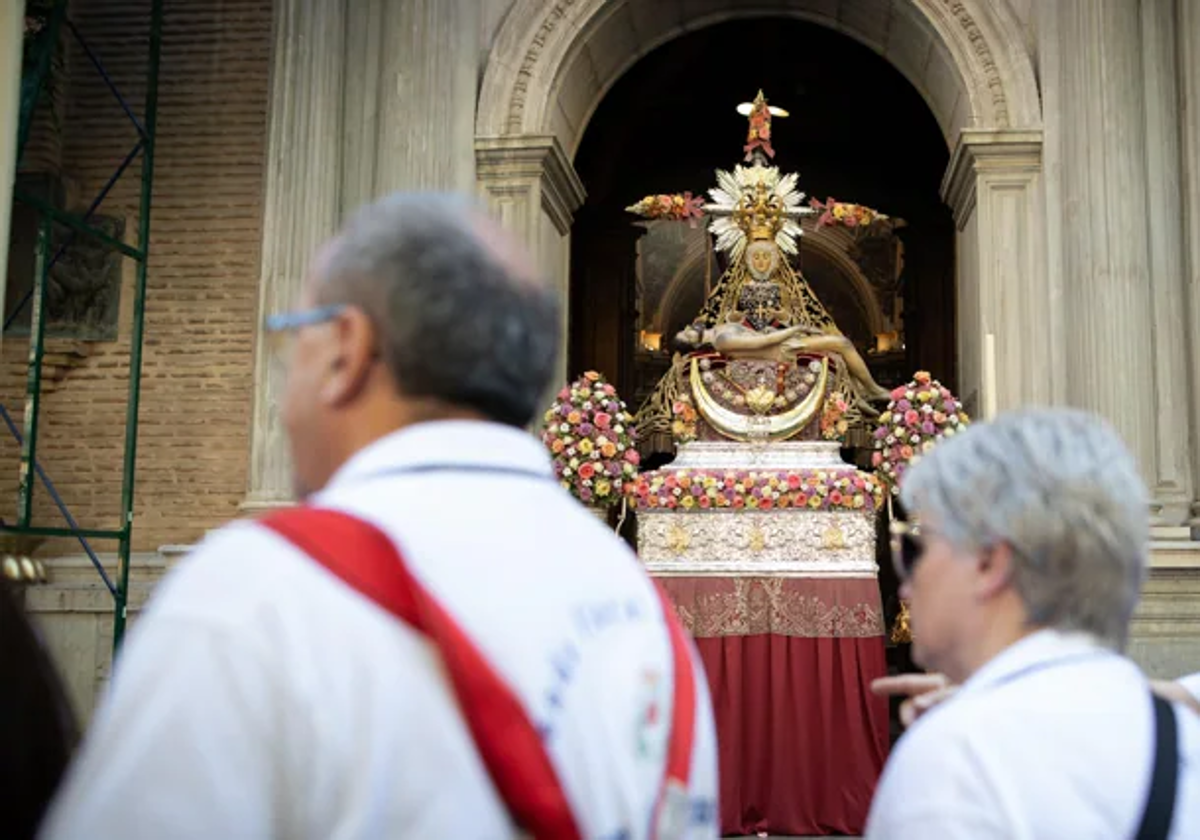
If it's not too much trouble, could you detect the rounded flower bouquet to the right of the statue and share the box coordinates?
[871,371,971,494]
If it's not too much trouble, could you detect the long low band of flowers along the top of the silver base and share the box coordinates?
[629,469,883,512]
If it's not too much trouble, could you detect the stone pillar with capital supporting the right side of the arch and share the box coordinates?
[942,130,1064,413]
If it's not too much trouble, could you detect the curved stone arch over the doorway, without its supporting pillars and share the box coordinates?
[475,0,1042,155]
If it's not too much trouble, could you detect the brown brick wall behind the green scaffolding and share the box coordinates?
[0,0,271,553]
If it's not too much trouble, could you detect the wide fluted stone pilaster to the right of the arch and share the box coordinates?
[1038,0,1160,516]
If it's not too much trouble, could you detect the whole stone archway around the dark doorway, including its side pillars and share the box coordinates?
[475,0,1046,417]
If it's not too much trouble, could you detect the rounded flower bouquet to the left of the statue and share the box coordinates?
[541,371,641,508]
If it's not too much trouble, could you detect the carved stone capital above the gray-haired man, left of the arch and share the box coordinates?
[475,134,587,236]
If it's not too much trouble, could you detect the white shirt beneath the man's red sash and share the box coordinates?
[43,422,718,840]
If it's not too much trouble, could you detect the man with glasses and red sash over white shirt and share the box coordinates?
[44,193,718,840]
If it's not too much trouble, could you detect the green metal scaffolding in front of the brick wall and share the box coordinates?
[9,0,162,648]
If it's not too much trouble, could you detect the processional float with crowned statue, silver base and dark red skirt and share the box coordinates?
[626,91,966,835]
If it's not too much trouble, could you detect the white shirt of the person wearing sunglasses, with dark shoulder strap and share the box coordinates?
[866,630,1200,840]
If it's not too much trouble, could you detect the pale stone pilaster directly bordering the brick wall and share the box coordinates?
[242,0,347,510]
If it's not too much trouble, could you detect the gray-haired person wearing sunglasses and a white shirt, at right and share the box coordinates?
[866,409,1200,840]
